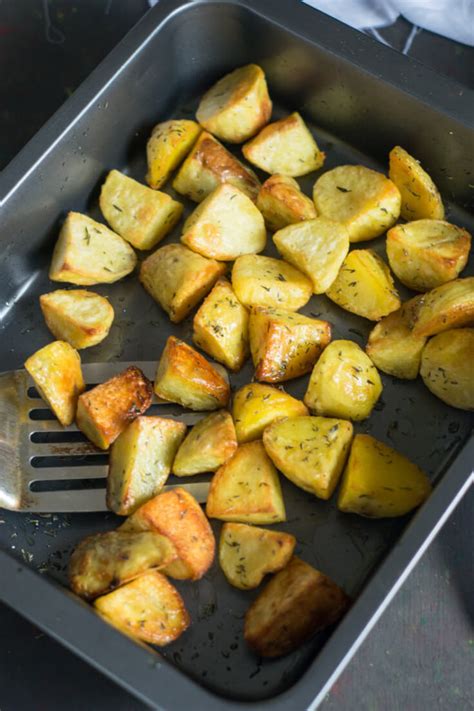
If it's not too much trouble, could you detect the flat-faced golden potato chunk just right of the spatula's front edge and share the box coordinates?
[206,441,286,524]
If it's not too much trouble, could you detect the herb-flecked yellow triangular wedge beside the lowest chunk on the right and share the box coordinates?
[263,417,353,499]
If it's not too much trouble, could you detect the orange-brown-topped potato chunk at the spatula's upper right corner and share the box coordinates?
[155,336,230,410]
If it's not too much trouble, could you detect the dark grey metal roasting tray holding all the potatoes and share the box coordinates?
[0,0,474,711]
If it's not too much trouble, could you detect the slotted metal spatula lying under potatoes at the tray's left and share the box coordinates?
[0,361,209,513]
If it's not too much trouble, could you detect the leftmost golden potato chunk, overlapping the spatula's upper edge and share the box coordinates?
[25,341,86,427]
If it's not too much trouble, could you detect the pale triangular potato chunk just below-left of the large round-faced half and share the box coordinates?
[273,217,349,294]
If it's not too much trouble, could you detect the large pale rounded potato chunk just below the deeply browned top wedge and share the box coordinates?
[181,183,267,261]
